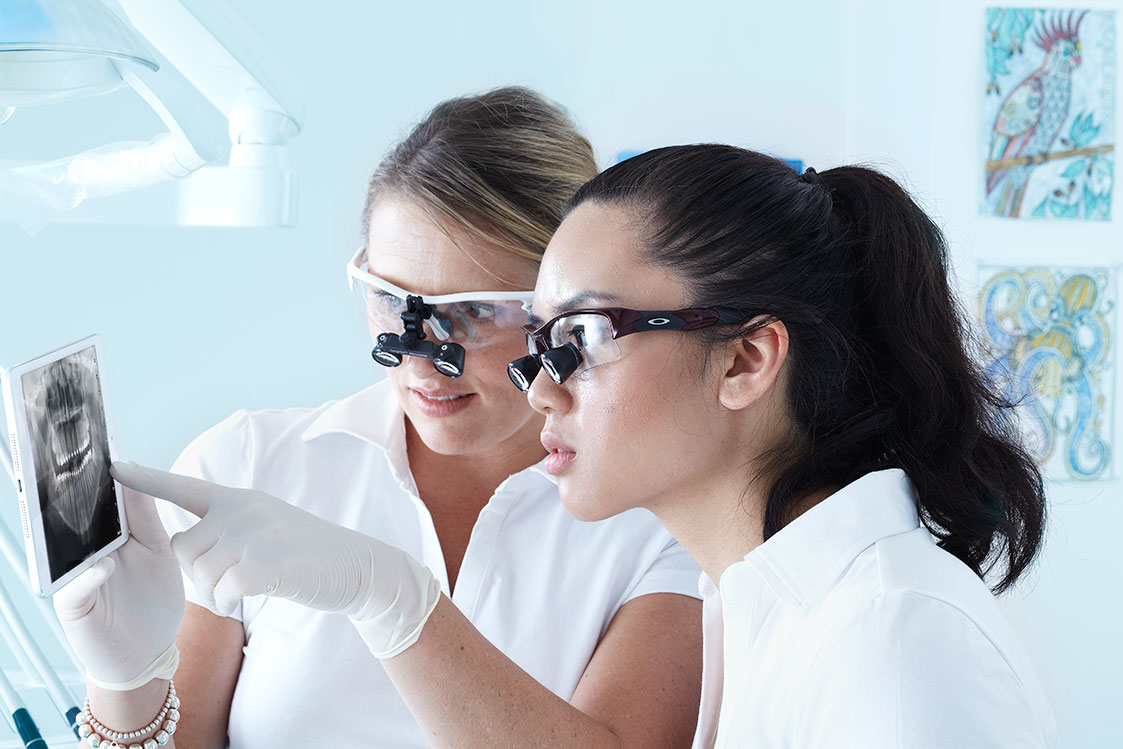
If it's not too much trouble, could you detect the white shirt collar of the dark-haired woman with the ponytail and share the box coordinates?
[719,468,920,611]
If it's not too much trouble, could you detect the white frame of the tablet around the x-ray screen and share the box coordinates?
[0,336,129,597]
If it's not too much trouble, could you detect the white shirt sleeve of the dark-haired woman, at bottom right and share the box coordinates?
[796,592,1051,749]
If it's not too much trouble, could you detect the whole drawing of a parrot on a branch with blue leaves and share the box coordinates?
[982,8,1116,220]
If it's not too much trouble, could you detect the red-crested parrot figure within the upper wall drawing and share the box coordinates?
[986,11,1087,218]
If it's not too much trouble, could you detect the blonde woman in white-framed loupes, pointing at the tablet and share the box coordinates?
[56,88,701,748]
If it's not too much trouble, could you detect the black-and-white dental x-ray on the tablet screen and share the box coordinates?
[22,346,121,581]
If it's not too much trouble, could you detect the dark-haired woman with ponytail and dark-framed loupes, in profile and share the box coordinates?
[512,145,1054,749]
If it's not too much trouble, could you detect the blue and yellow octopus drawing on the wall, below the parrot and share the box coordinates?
[979,268,1112,481]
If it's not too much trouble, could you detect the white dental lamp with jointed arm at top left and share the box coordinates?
[0,0,303,234]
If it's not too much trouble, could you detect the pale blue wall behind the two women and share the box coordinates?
[0,0,1123,747]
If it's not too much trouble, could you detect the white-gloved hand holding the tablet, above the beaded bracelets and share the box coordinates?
[54,480,185,688]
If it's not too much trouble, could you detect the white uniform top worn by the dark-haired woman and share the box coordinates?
[694,469,1056,749]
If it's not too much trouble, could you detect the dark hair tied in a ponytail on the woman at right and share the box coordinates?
[569,145,1046,592]
